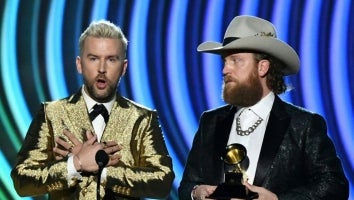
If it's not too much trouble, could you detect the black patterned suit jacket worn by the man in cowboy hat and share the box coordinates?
[179,96,349,200]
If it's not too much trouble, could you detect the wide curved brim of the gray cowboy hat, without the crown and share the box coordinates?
[197,36,300,75]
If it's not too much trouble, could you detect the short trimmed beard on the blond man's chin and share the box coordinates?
[83,75,117,103]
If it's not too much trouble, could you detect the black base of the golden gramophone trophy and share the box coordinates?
[208,183,258,200]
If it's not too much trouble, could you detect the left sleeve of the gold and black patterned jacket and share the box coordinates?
[11,104,68,196]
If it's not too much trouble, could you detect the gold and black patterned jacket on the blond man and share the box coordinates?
[11,92,174,199]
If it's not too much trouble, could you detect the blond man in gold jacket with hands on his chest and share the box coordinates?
[11,21,174,199]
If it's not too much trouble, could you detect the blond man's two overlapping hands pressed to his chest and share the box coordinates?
[53,130,122,172]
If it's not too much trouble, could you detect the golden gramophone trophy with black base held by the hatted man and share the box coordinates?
[208,143,258,200]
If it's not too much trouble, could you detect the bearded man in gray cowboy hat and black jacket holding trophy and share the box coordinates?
[179,16,349,200]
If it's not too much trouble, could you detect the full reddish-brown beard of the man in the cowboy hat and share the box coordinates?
[222,72,263,107]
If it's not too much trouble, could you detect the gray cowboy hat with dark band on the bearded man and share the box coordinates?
[197,15,300,75]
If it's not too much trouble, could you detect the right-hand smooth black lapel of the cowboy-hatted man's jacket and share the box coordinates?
[253,96,290,186]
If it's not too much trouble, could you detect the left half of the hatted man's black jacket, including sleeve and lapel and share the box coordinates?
[178,106,234,200]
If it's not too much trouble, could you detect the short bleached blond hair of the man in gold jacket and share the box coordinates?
[79,20,128,56]
